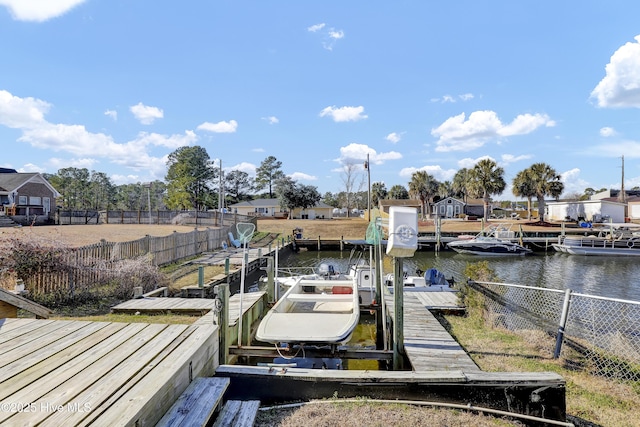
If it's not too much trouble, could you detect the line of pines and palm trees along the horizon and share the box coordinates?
[45,146,608,221]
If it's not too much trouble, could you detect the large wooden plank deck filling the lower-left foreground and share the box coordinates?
[0,314,218,426]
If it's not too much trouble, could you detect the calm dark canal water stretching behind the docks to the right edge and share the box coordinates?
[280,251,640,301]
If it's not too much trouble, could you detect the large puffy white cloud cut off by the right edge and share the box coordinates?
[591,35,640,108]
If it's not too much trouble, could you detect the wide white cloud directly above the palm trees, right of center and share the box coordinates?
[431,110,555,152]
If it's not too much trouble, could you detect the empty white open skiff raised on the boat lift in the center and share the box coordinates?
[256,277,360,345]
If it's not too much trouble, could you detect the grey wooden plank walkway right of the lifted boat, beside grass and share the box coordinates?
[390,292,480,372]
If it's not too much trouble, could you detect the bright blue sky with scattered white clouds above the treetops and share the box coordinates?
[0,0,640,200]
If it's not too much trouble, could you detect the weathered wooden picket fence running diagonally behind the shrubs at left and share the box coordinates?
[24,216,255,299]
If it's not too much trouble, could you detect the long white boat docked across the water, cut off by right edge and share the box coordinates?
[552,223,640,256]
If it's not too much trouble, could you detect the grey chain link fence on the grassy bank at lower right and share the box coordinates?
[467,280,640,381]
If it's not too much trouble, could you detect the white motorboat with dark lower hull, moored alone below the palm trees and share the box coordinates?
[447,224,532,256]
